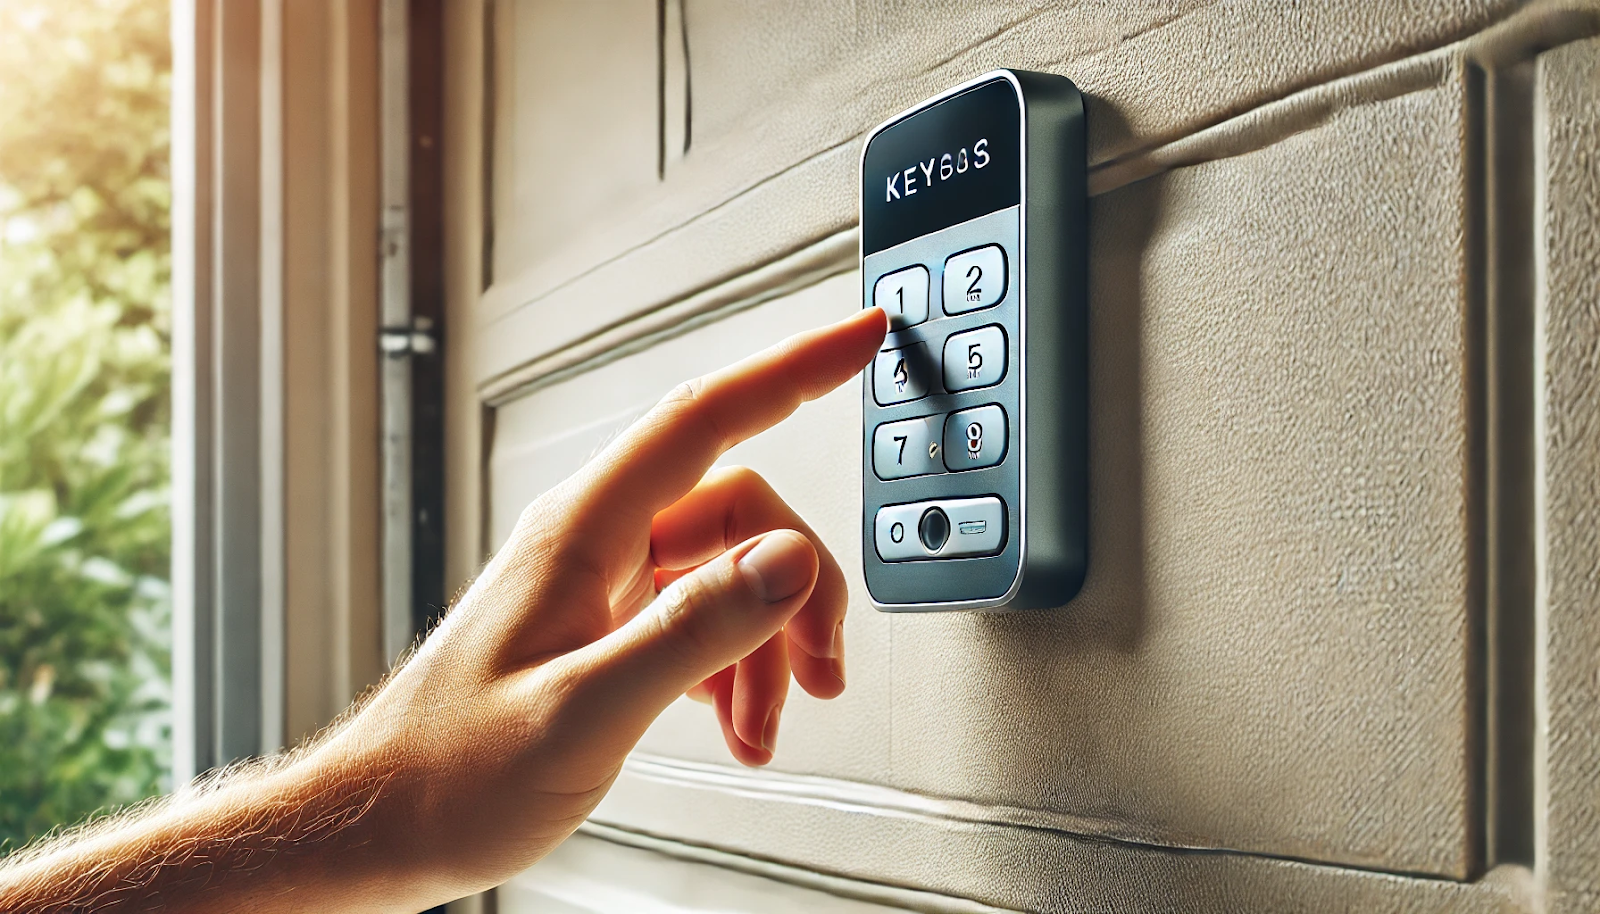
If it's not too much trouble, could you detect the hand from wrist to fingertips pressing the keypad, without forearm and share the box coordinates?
[302,309,885,900]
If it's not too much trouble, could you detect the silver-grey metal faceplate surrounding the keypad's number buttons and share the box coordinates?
[861,206,1024,608]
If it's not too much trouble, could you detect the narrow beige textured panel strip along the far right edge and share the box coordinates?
[1536,40,1600,912]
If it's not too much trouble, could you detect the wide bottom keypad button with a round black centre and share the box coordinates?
[872,495,1005,562]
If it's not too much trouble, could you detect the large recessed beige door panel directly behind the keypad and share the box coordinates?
[491,68,1474,876]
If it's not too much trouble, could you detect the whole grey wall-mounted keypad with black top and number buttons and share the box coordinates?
[861,69,1088,611]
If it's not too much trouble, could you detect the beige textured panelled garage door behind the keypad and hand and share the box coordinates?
[448,0,1600,911]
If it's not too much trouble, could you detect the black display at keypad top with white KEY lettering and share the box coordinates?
[861,80,1022,256]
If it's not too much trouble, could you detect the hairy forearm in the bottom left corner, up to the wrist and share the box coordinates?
[0,759,408,914]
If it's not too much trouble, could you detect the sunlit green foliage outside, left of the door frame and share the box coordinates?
[0,0,171,847]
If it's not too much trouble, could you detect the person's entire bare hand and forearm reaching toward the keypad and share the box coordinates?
[0,309,886,912]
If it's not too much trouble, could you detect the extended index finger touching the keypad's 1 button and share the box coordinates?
[579,307,888,557]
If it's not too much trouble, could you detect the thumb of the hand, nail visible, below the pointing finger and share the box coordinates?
[563,530,819,745]
